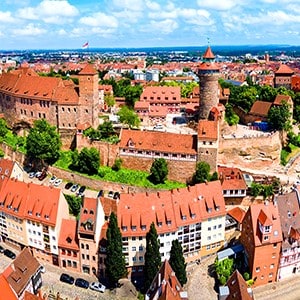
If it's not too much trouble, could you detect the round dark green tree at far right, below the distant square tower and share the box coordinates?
[268,101,291,131]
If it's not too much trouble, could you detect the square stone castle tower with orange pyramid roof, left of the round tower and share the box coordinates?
[78,64,99,128]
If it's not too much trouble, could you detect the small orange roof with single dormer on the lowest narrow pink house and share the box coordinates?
[58,219,79,250]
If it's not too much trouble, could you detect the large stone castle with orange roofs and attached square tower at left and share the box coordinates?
[0,64,99,145]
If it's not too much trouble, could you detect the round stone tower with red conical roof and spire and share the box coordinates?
[198,46,220,120]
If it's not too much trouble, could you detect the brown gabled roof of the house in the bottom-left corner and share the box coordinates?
[6,247,40,296]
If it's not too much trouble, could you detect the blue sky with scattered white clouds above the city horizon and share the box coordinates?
[0,0,300,50]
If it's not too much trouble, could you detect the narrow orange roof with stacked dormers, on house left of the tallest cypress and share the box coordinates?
[78,197,100,234]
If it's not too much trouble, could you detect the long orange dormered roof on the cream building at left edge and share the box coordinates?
[0,179,60,226]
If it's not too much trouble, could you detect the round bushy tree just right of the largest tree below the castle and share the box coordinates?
[71,147,100,175]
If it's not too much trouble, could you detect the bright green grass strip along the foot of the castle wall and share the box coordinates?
[54,151,186,190]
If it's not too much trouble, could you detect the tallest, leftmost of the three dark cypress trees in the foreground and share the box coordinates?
[105,212,126,286]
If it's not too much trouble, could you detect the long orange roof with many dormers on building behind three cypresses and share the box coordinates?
[117,181,226,236]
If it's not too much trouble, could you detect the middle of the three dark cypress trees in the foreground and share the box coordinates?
[144,222,161,291]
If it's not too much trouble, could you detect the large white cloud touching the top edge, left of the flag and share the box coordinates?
[17,0,79,24]
